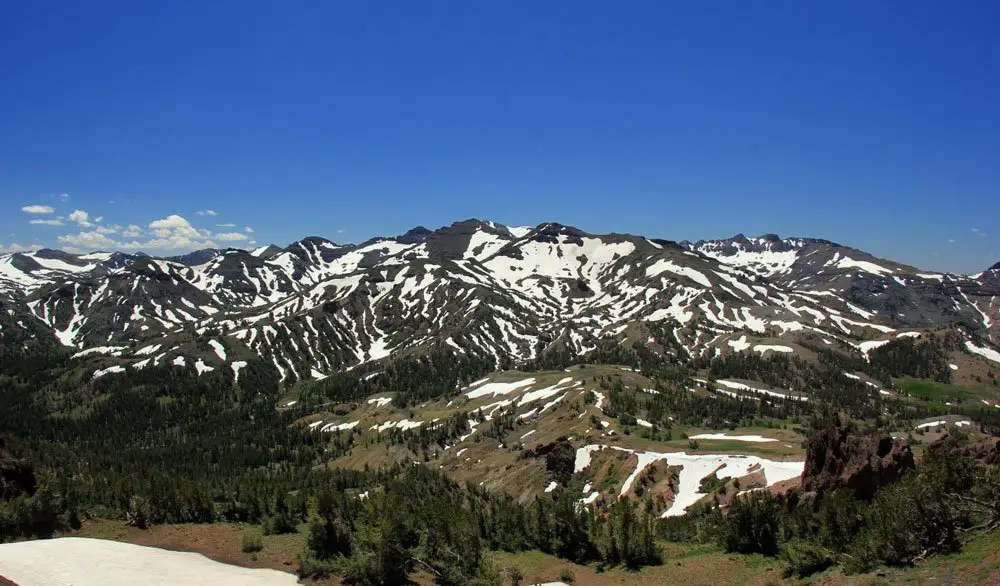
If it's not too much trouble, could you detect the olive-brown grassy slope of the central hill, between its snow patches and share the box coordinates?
[316,365,805,502]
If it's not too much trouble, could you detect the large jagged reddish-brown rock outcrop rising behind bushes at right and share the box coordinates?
[802,419,915,500]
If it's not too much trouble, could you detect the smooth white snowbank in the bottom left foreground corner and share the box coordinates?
[0,537,298,586]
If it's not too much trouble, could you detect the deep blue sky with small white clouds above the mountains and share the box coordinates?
[0,0,1000,272]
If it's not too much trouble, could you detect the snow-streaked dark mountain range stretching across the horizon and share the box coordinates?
[0,220,1000,382]
